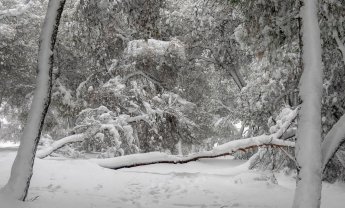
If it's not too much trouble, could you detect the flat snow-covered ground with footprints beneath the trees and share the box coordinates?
[0,147,345,208]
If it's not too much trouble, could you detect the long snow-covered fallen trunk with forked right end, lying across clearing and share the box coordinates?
[95,109,298,169]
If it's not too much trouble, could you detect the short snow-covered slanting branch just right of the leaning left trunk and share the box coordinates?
[36,134,87,159]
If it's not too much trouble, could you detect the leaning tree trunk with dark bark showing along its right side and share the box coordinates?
[1,0,65,201]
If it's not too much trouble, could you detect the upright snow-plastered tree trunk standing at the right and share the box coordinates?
[293,0,323,208]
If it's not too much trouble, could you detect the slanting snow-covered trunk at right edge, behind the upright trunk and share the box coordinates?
[321,115,345,170]
